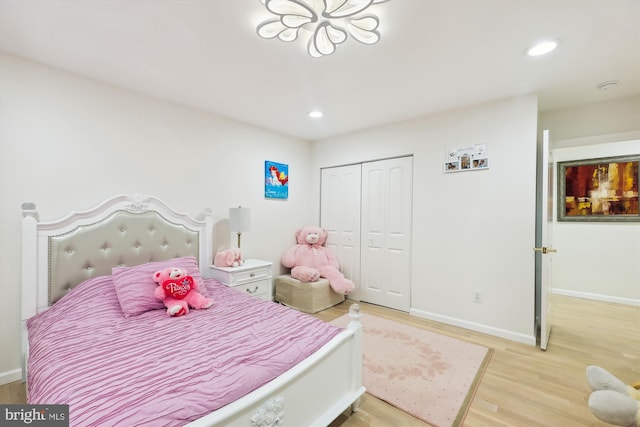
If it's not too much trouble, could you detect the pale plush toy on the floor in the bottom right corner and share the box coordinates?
[587,366,640,427]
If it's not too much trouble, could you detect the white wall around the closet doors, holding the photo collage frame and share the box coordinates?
[313,96,538,344]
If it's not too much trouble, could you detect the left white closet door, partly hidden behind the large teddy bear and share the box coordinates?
[320,164,362,301]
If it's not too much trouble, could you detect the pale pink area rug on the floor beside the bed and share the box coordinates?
[331,314,491,427]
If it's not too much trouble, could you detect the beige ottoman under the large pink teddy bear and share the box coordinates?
[275,274,345,313]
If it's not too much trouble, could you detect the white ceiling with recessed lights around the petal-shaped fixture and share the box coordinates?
[0,0,640,140]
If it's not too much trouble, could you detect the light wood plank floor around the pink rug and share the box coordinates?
[0,295,640,427]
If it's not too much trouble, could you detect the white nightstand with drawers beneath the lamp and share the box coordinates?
[211,259,273,301]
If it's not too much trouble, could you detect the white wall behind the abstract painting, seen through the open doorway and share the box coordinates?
[552,140,640,305]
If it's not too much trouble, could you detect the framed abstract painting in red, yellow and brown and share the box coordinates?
[558,155,640,222]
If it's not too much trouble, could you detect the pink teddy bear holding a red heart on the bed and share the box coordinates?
[153,267,213,316]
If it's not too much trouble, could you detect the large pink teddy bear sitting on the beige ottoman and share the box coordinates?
[281,225,355,295]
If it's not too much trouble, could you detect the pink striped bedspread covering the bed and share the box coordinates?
[28,276,341,426]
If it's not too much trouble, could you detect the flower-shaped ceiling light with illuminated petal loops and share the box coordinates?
[257,0,389,58]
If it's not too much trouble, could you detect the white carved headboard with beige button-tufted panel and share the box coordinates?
[22,195,213,320]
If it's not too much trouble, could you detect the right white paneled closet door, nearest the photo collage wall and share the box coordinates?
[360,157,413,311]
